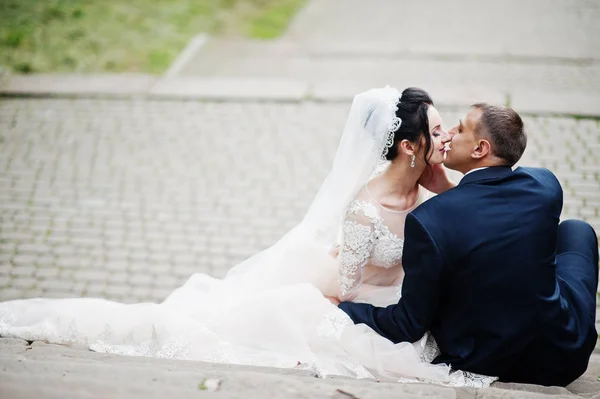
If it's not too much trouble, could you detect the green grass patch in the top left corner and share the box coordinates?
[0,0,306,73]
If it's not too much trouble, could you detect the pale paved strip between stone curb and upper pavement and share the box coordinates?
[181,44,600,93]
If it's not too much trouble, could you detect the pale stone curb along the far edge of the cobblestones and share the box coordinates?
[0,74,600,118]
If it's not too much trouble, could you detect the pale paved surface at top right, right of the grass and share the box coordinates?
[288,0,600,61]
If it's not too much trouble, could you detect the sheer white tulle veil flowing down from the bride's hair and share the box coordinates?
[193,87,401,299]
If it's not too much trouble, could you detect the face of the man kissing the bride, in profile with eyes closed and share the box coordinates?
[444,108,481,173]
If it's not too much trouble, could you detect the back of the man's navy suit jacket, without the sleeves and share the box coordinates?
[413,167,564,380]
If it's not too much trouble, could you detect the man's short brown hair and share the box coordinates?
[472,103,527,166]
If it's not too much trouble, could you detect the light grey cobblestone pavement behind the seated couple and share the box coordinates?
[0,99,600,302]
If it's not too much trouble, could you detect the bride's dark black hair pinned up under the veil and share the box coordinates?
[386,87,433,165]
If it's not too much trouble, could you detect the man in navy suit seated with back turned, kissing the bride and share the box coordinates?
[339,104,598,386]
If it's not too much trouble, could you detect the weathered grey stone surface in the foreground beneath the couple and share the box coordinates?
[0,339,600,399]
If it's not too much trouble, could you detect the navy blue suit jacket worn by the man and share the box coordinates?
[340,167,596,385]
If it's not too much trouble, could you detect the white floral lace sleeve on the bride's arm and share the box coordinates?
[339,204,375,299]
